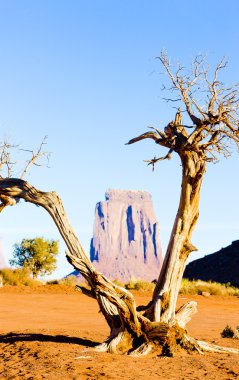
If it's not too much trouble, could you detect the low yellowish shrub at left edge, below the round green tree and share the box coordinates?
[0,268,42,286]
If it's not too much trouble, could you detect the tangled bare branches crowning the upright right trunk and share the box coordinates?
[128,51,239,169]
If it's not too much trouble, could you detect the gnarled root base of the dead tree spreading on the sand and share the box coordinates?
[85,301,239,357]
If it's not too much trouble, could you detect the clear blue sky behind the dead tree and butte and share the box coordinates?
[0,0,239,277]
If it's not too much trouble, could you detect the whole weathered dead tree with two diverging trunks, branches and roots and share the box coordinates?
[0,53,239,355]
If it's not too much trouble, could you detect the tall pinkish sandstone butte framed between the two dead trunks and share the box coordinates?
[90,189,162,282]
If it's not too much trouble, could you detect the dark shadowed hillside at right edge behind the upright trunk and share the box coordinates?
[184,240,239,286]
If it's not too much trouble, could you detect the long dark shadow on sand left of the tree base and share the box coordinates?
[0,332,99,347]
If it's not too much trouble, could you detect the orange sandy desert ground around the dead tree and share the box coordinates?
[0,286,239,380]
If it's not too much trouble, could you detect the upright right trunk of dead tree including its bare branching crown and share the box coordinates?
[123,47,239,352]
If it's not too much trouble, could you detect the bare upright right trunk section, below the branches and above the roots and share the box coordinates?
[153,152,205,323]
